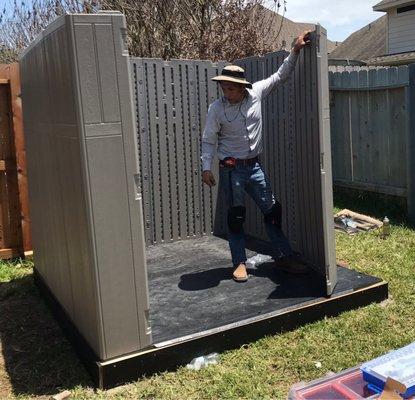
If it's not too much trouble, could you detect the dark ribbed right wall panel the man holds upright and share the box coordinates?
[238,27,335,282]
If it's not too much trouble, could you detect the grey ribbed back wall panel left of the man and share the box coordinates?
[132,58,226,245]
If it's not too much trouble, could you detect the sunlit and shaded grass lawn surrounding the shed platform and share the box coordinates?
[0,193,415,399]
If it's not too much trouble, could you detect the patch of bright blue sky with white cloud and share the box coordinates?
[269,0,384,42]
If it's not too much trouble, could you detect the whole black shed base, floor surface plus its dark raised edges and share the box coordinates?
[34,236,388,389]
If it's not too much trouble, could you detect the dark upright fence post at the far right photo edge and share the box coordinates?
[406,64,415,225]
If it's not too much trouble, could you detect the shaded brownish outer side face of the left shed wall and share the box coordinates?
[20,17,102,354]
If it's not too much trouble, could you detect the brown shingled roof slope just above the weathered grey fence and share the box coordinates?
[329,15,387,60]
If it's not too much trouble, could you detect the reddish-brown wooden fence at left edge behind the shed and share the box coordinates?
[0,64,32,258]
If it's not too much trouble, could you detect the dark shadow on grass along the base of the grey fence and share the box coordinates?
[333,187,413,228]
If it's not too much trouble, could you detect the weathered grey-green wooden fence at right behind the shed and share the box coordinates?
[329,65,415,222]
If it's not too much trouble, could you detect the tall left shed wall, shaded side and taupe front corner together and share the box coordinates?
[21,13,151,360]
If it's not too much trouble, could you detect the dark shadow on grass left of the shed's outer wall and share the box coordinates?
[0,275,91,396]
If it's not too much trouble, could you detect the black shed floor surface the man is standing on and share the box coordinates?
[147,236,381,344]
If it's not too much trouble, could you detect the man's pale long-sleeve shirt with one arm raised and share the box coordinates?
[202,51,298,171]
